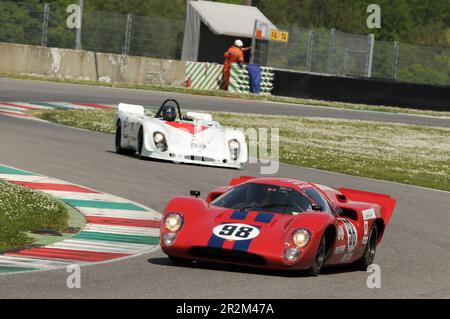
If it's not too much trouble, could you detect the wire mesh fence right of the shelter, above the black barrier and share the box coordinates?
[253,22,450,85]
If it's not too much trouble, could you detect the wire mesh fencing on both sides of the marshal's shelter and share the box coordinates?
[0,1,450,85]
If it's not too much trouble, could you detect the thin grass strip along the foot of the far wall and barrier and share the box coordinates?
[0,74,450,117]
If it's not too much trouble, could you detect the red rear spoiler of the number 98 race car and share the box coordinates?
[339,188,397,225]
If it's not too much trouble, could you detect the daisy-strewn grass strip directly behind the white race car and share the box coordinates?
[34,110,450,191]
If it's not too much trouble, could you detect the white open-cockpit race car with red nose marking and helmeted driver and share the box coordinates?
[114,99,248,168]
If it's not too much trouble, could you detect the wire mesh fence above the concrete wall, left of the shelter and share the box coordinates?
[0,1,184,59]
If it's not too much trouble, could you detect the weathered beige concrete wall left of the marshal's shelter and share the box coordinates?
[0,43,186,86]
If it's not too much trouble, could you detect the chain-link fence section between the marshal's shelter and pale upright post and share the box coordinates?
[254,26,373,76]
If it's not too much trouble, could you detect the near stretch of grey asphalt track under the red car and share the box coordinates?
[0,115,450,300]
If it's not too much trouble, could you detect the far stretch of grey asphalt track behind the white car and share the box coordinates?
[0,78,450,127]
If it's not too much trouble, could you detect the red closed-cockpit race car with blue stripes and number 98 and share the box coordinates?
[161,176,395,276]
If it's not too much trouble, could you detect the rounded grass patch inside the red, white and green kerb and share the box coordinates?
[0,181,69,250]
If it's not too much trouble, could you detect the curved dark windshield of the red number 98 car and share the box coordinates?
[211,183,312,214]
